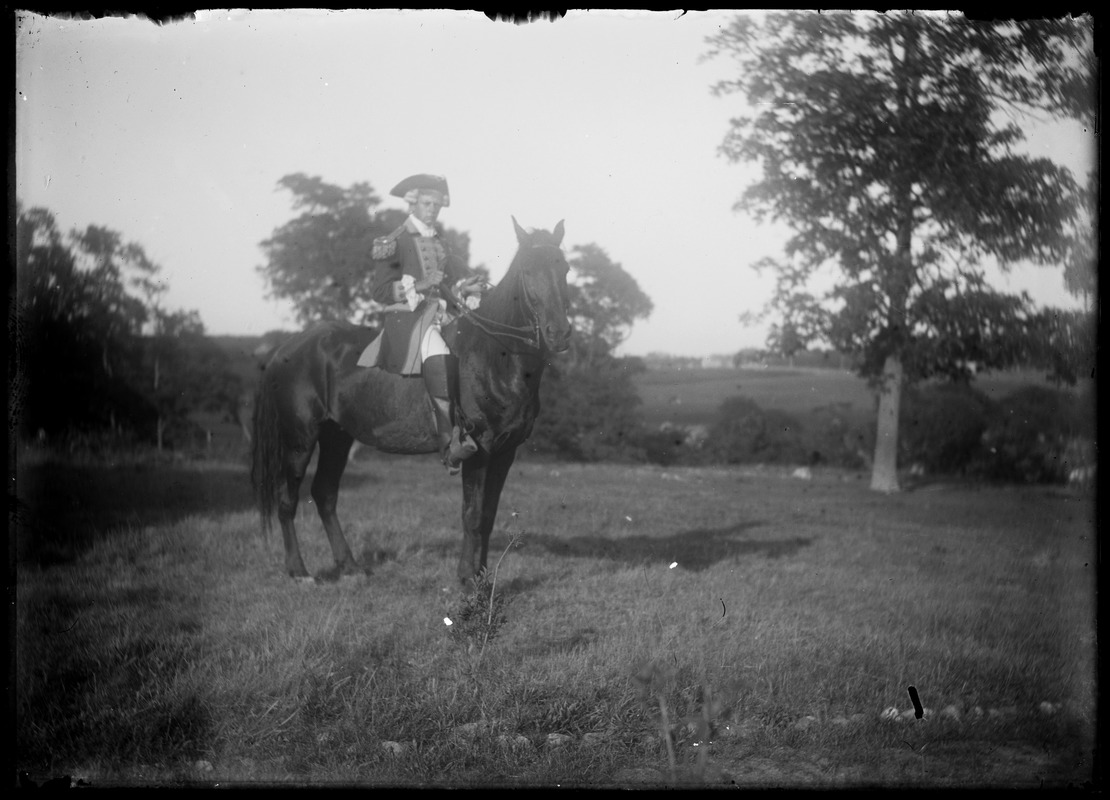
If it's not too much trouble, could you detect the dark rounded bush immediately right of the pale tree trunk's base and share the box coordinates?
[899,382,995,474]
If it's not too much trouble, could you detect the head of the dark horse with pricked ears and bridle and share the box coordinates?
[513,216,573,353]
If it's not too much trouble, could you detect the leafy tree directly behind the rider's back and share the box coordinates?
[258,172,484,325]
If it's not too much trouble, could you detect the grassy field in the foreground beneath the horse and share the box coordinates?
[12,446,1101,788]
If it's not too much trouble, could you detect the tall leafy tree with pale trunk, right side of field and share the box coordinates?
[709,12,1093,492]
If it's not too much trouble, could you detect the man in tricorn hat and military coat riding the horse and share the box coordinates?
[359,174,482,475]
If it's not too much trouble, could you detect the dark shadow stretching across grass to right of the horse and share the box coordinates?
[525,521,811,573]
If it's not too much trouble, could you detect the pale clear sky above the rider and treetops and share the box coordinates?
[16,10,1094,356]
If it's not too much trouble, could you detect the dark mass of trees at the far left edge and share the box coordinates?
[9,203,239,442]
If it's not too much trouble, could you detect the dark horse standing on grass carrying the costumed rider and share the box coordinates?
[251,219,571,584]
